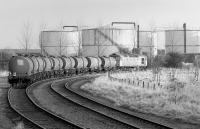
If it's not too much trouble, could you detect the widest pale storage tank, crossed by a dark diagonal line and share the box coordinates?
[82,23,137,56]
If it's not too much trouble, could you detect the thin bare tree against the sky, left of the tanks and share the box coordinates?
[19,21,32,52]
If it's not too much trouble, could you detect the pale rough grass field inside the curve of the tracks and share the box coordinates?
[81,69,200,123]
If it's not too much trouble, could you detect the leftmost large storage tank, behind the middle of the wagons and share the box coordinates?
[40,31,81,56]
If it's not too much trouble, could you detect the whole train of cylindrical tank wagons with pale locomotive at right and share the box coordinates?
[8,54,147,88]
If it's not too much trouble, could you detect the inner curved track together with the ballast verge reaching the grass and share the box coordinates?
[51,75,199,129]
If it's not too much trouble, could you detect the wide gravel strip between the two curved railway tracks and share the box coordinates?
[27,75,133,129]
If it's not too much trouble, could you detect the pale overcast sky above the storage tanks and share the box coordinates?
[0,0,200,49]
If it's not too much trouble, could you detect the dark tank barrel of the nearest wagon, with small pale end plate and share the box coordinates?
[9,56,33,77]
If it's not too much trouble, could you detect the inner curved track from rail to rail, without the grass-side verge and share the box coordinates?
[51,78,168,129]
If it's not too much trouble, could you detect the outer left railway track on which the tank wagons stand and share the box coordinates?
[8,79,79,129]
